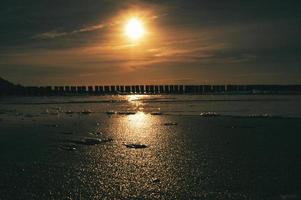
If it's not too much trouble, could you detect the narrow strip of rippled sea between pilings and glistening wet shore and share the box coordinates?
[0,95,301,117]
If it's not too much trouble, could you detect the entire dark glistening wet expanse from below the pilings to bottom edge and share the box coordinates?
[0,96,301,200]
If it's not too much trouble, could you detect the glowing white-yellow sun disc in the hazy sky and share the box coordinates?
[125,17,145,40]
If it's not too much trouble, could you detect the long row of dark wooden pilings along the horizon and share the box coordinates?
[11,85,301,95]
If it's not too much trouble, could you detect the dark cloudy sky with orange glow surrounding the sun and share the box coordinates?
[0,0,301,85]
